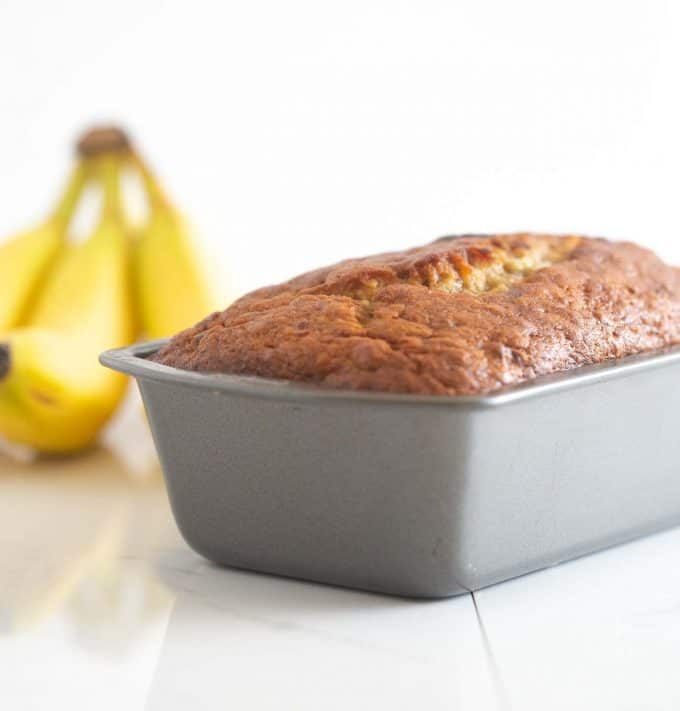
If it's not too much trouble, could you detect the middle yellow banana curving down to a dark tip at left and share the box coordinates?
[0,155,135,452]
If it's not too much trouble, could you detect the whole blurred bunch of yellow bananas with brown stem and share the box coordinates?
[0,129,215,452]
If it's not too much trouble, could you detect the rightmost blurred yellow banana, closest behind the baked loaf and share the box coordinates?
[132,155,217,338]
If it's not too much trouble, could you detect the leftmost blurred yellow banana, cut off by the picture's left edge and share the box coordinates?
[0,163,84,333]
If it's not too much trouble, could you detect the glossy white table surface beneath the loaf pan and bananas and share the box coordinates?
[0,451,680,711]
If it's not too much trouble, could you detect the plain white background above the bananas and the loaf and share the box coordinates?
[0,0,680,300]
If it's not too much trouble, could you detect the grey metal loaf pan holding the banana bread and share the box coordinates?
[101,342,680,597]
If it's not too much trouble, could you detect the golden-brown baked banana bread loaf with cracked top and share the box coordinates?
[153,234,680,395]
